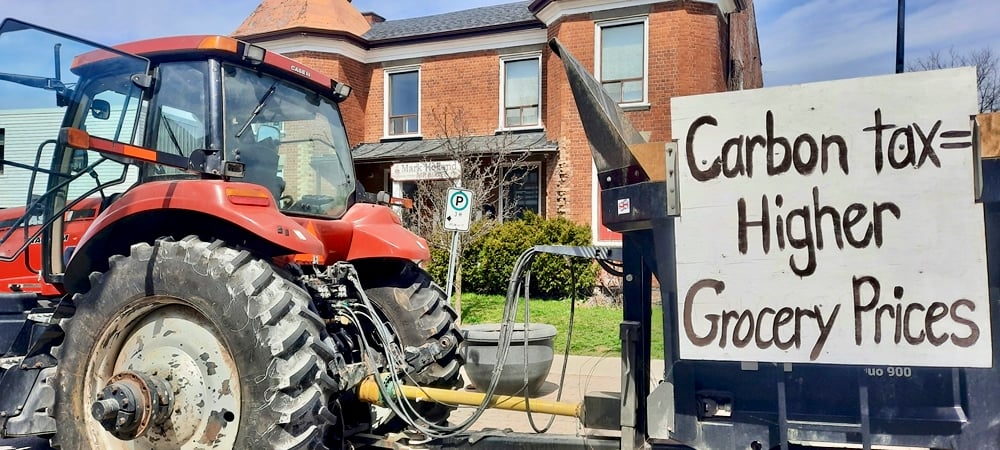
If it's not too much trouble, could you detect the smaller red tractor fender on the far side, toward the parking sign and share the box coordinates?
[343,204,431,262]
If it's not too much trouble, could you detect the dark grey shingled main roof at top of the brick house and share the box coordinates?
[362,1,542,43]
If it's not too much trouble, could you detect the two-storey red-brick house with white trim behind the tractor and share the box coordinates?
[233,0,762,241]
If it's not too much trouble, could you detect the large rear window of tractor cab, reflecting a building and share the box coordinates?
[223,66,355,217]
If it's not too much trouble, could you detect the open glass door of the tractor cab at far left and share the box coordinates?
[0,19,149,260]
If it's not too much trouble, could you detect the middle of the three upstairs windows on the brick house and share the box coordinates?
[500,56,542,128]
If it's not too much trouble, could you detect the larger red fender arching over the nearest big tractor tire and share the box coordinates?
[63,180,325,292]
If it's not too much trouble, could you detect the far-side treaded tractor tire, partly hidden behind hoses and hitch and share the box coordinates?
[355,261,464,432]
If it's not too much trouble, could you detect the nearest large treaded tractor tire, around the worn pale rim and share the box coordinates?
[53,237,335,450]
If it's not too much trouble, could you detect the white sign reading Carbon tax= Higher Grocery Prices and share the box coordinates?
[671,68,992,367]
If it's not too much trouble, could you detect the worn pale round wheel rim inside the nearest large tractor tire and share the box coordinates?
[84,297,241,450]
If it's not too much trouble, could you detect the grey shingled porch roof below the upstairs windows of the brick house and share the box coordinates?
[353,131,559,162]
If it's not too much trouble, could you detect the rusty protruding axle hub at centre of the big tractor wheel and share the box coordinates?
[90,371,174,441]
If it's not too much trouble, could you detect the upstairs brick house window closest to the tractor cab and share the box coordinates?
[385,68,420,136]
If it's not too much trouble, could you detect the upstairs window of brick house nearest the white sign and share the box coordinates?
[597,18,647,104]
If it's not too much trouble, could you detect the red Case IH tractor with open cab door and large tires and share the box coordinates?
[0,19,462,449]
